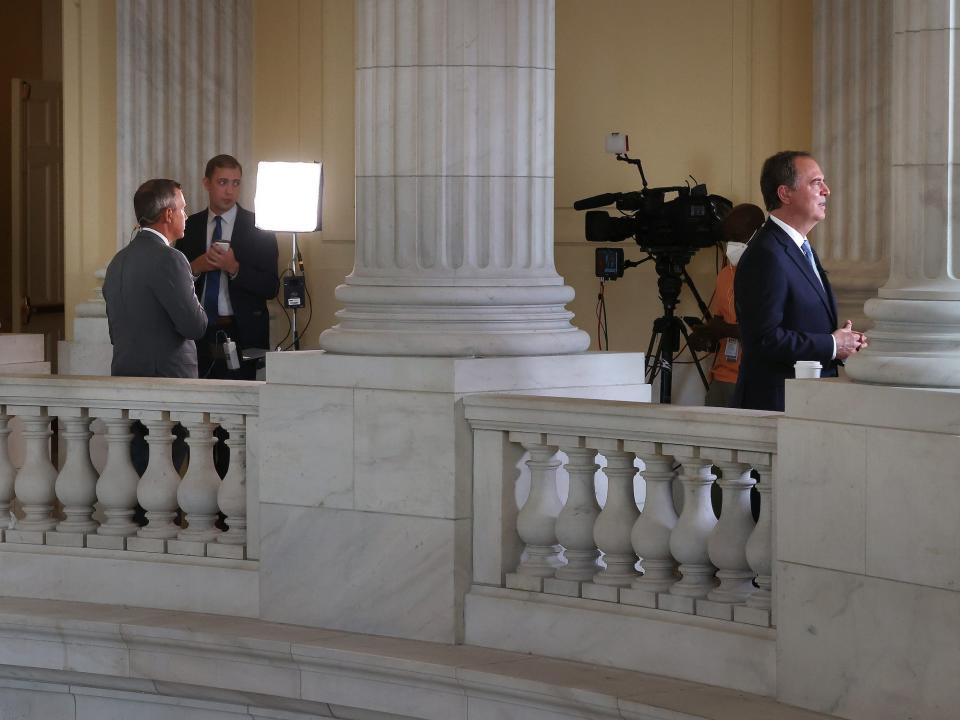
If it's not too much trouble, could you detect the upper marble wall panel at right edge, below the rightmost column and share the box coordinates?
[866,428,960,590]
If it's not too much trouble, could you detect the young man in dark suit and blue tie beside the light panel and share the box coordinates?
[177,155,280,380]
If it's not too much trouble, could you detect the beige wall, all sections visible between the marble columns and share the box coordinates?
[64,0,812,358]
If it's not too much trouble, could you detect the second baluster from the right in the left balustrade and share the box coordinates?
[170,413,220,553]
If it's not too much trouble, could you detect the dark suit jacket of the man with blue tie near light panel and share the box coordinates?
[177,205,280,348]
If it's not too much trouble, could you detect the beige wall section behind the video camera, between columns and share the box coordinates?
[555,0,812,362]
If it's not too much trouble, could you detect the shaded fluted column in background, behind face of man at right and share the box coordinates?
[811,0,893,327]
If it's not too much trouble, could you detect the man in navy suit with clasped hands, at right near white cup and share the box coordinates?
[731,151,867,410]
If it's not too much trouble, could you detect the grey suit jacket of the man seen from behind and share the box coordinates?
[103,230,207,378]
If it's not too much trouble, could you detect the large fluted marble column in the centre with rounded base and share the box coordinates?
[320,0,589,356]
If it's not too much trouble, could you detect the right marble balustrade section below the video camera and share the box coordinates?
[464,395,779,627]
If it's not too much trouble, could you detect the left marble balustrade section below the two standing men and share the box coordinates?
[0,375,262,559]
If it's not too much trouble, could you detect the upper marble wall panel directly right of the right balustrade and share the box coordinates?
[774,418,867,573]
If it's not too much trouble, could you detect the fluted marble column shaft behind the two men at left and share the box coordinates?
[117,0,253,248]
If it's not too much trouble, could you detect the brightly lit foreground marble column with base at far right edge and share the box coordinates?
[847,0,960,387]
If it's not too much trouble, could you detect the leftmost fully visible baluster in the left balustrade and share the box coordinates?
[7,407,57,544]
